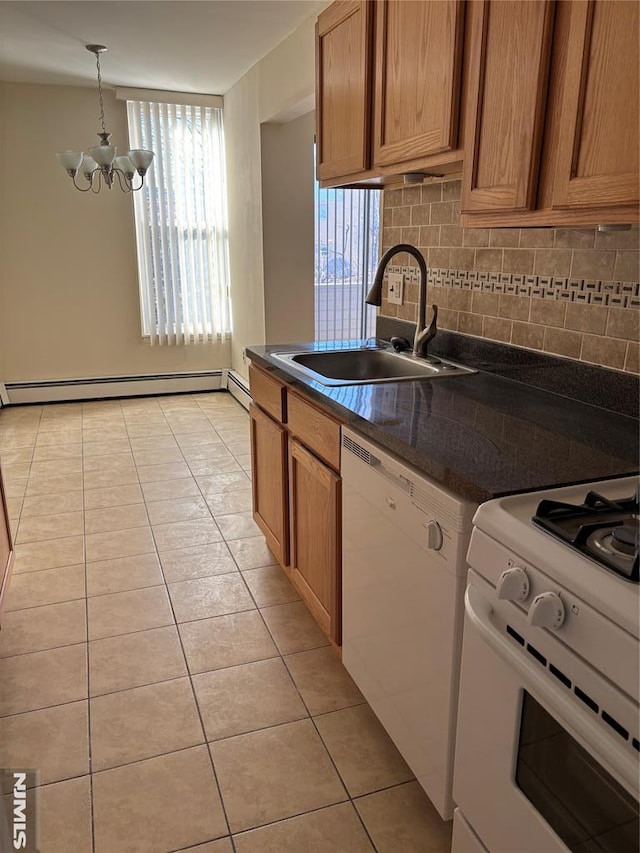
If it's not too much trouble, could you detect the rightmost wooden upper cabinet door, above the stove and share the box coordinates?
[553,0,640,208]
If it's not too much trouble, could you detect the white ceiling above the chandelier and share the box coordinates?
[0,0,326,95]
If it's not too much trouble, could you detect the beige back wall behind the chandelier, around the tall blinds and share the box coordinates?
[0,83,230,382]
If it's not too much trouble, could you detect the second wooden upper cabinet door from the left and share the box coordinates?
[373,0,464,166]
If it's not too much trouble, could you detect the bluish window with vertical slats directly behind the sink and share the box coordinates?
[314,182,381,341]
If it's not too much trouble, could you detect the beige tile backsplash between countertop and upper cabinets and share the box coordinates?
[380,180,640,373]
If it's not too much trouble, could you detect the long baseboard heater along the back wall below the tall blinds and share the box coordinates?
[4,369,229,405]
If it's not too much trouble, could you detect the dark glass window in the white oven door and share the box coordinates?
[516,691,640,853]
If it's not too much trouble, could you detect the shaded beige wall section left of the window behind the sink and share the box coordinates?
[262,112,315,344]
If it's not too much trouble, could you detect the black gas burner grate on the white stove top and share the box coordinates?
[532,491,640,583]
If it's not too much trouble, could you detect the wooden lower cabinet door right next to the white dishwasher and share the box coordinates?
[289,439,342,645]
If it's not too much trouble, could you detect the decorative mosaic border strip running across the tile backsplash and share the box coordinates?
[388,266,640,308]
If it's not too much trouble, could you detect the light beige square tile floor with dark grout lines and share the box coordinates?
[0,392,450,853]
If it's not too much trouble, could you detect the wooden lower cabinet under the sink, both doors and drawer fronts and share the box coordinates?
[249,364,342,646]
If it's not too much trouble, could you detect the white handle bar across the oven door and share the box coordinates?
[464,582,638,797]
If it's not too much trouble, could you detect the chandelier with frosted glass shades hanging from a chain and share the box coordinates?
[56,44,153,193]
